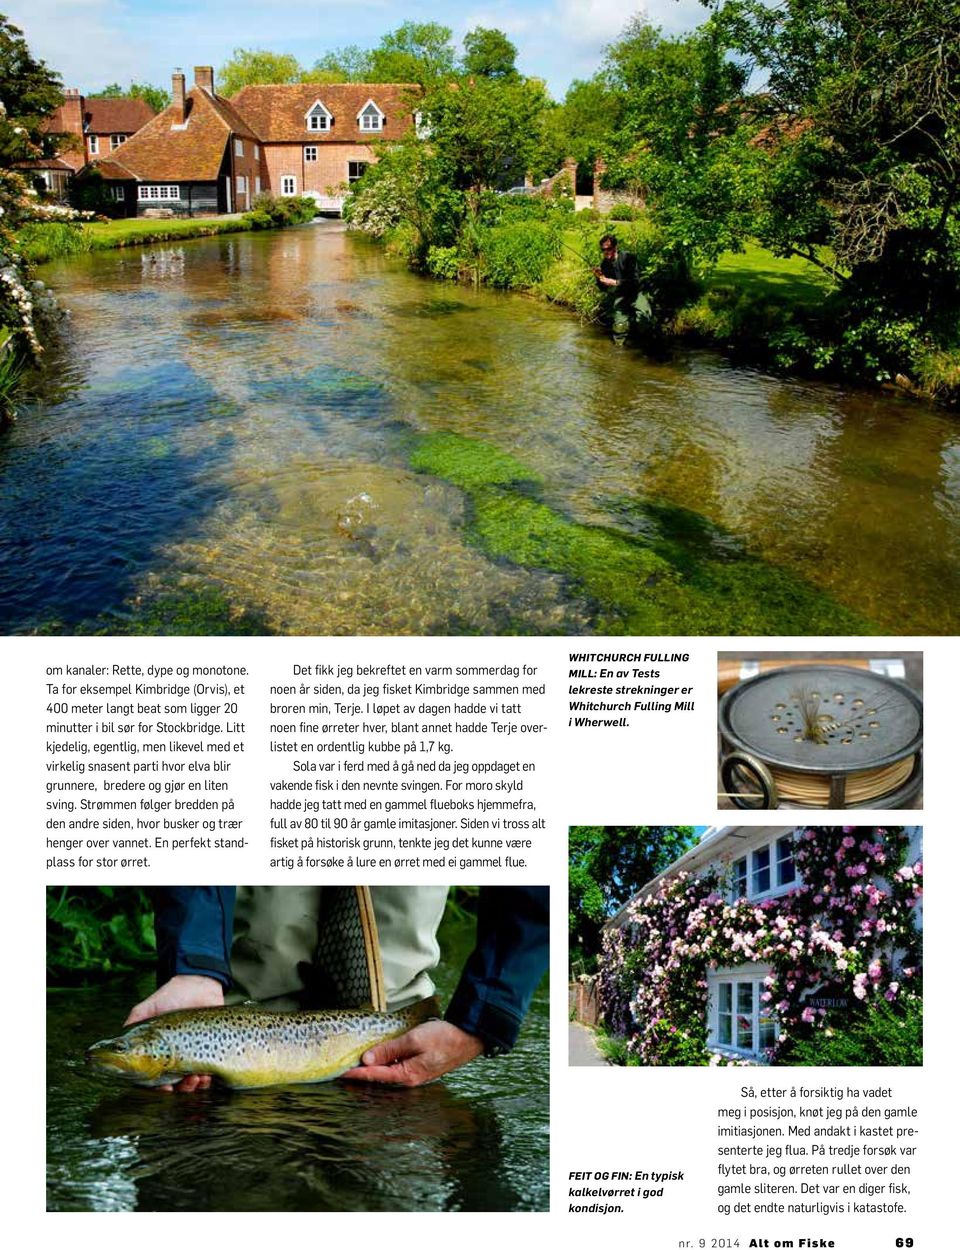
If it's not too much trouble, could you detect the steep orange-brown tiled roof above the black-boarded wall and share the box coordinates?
[101,86,258,183]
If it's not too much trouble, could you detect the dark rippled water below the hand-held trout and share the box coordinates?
[48,935,549,1211]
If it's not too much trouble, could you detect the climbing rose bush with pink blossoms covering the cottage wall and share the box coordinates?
[598,825,924,1065]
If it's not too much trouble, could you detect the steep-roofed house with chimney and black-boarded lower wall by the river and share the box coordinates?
[90,65,263,216]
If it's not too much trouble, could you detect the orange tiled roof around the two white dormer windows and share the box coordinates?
[231,83,420,144]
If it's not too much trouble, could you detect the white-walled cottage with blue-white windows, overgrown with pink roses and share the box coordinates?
[600,825,923,1063]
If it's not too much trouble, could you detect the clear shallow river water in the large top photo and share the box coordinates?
[7,223,960,634]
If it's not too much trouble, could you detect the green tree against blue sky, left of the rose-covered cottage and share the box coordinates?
[568,825,696,964]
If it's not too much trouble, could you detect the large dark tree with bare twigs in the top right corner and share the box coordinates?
[718,0,960,339]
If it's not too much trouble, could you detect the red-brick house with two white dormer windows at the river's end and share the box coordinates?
[231,83,420,213]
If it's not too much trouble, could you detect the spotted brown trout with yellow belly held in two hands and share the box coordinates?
[86,999,438,1089]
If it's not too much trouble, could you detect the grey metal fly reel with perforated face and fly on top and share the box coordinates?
[719,664,924,809]
